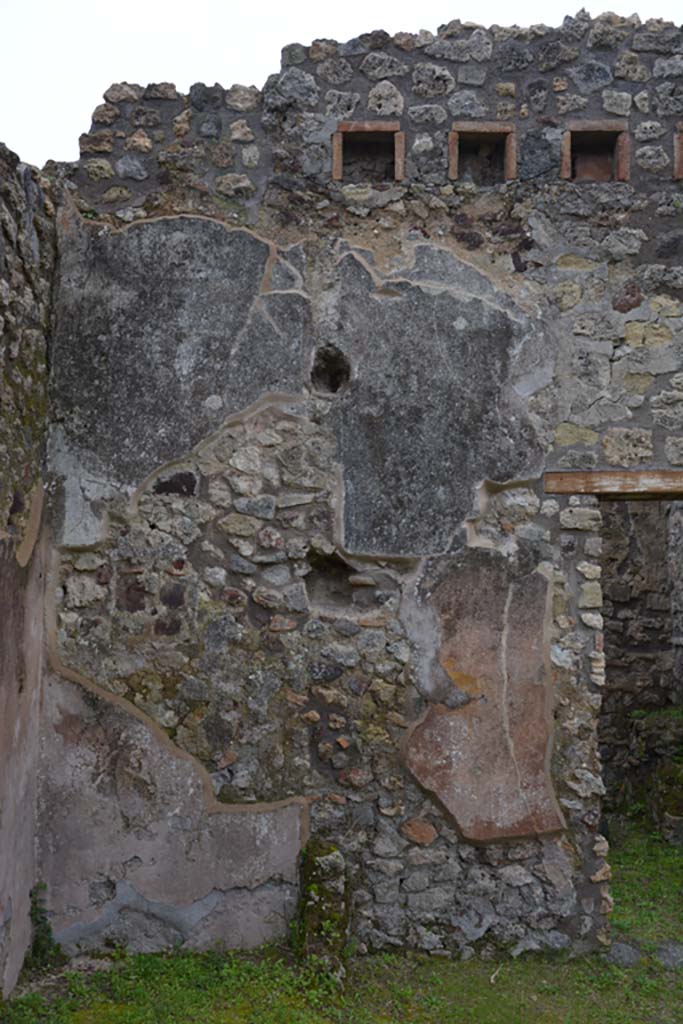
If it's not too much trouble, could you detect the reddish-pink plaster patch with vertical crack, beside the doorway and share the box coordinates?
[405,549,564,842]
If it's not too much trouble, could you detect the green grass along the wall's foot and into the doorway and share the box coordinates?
[0,823,683,1024]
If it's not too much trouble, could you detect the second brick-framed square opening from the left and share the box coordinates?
[449,121,517,185]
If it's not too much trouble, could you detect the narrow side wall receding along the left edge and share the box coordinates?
[0,146,54,994]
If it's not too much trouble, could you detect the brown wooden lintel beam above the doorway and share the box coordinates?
[544,469,683,498]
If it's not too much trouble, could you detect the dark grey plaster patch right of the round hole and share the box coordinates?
[330,247,541,554]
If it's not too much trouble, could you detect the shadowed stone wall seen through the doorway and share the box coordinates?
[600,501,683,810]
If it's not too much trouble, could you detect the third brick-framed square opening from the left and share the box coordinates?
[561,122,629,181]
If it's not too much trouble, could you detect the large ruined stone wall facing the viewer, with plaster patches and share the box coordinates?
[3,6,683,983]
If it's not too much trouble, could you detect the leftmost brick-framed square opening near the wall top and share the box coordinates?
[332,121,405,184]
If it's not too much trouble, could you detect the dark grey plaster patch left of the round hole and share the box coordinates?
[53,211,308,491]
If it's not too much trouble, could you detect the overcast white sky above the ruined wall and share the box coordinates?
[0,0,683,167]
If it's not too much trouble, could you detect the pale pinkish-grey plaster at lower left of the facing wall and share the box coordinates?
[40,675,305,951]
